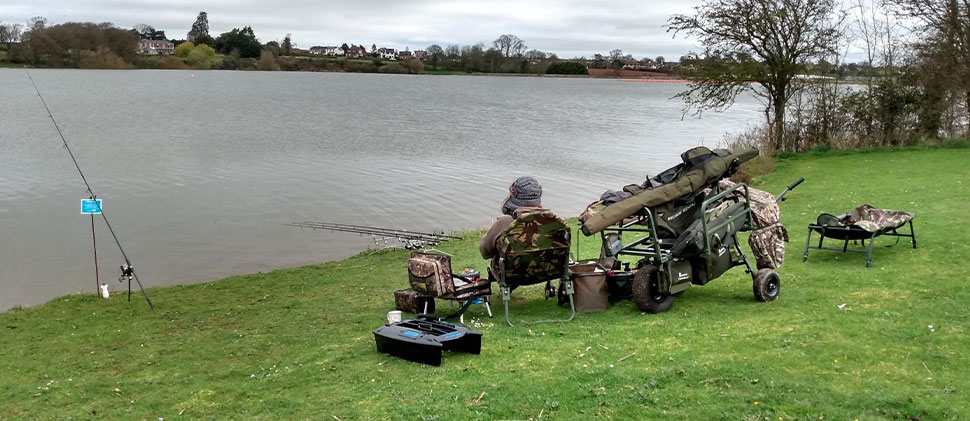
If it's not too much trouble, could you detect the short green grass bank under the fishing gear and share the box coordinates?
[0,149,970,420]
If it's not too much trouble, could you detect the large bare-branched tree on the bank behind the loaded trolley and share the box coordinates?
[667,0,845,150]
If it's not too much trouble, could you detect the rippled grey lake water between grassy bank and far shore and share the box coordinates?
[0,69,763,311]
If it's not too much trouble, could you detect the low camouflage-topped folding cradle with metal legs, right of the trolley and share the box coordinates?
[802,205,916,267]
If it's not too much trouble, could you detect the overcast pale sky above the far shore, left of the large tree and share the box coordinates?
[0,0,701,60]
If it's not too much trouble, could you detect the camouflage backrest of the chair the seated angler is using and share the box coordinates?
[500,210,570,286]
